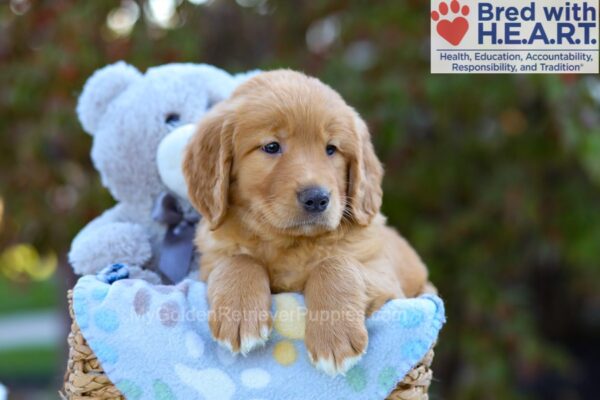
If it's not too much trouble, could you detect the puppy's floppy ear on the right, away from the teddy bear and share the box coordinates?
[348,114,383,226]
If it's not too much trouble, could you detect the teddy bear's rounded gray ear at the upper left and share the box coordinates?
[77,61,142,135]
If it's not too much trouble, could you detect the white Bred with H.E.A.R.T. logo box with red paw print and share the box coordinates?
[430,0,600,74]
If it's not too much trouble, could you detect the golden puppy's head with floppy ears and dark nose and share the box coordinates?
[184,70,383,236]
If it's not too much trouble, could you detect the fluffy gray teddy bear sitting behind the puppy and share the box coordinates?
[69,62,252,283]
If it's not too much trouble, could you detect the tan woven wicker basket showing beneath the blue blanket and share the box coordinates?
[60,289,435,400]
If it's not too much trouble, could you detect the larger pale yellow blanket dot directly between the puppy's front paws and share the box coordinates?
[273,293,306,339]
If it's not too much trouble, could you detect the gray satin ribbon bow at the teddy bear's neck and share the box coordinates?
[152,192,200,284]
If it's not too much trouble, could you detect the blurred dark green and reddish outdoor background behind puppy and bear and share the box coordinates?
[0,0,600,400]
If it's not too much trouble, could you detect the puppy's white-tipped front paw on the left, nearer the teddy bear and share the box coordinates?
[209,293,273,355]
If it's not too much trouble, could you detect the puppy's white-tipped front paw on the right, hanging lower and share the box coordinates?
[305,320,369,376]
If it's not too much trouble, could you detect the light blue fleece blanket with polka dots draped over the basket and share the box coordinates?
[73,276,445,400]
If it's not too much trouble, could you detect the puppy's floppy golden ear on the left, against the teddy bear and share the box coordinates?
[183,104,233,229]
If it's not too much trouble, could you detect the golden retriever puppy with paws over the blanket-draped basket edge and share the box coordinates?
[183,70,427,374]
